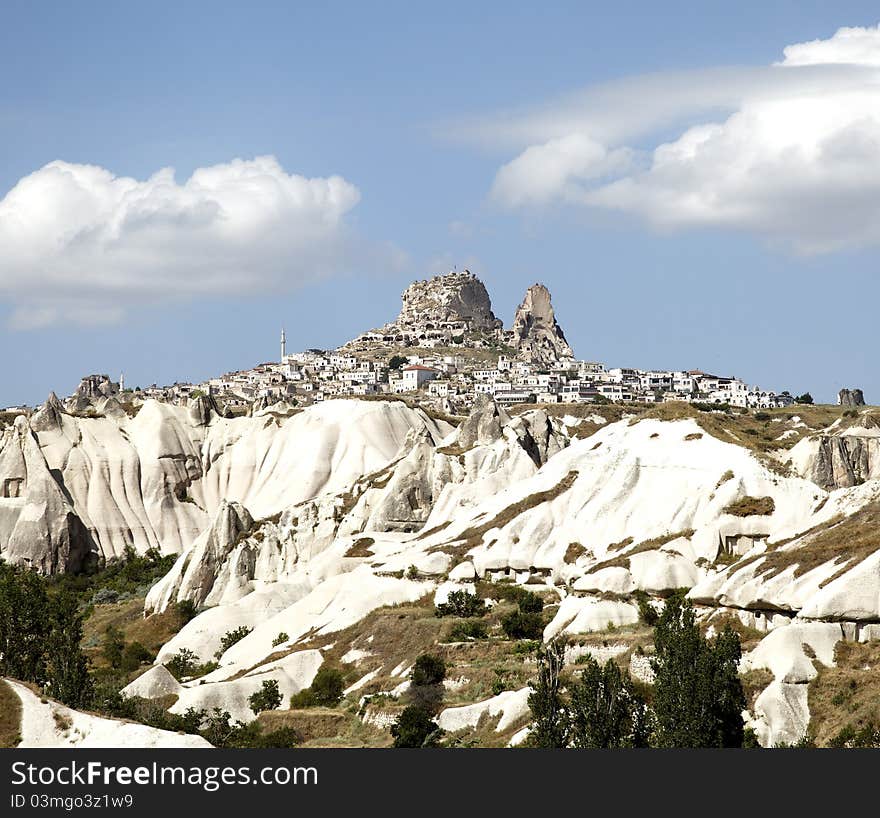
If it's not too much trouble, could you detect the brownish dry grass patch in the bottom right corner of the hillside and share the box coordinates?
[808,641,880,747]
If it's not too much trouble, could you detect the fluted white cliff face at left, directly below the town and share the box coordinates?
[0,396,450,573]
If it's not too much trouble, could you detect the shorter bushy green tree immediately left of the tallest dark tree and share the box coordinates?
[570,656,650,749]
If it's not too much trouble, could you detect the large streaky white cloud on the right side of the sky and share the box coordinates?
[478,27,880,252]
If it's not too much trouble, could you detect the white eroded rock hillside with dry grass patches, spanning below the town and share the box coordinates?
[0,386,880,744]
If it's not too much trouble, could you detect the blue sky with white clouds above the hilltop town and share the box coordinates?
[0,1,880,406]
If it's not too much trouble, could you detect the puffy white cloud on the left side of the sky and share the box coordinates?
[0,156,394,329]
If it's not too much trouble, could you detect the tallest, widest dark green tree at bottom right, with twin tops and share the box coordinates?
[651,594,746,747]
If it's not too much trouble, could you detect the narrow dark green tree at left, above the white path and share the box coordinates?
[46,591,94,707]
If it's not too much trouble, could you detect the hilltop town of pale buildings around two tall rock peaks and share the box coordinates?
[8,270,820,415]
